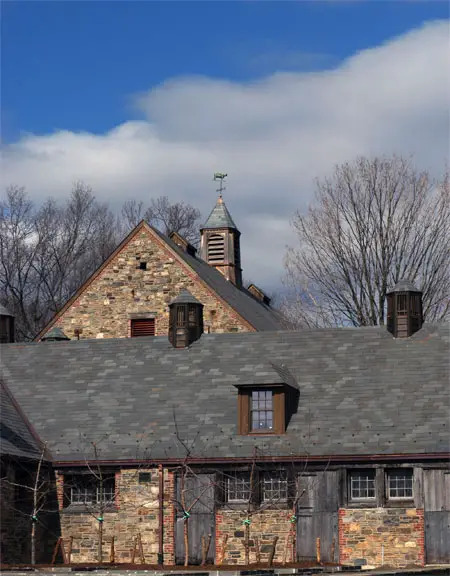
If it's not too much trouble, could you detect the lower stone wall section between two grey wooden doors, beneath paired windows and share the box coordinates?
[216,509,295,564]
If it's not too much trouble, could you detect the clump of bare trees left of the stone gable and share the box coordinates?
[0,183,120,340]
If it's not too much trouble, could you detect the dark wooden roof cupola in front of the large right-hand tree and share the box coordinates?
[386,280,423,338]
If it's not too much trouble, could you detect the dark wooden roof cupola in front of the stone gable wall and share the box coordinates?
[169,290,203,348]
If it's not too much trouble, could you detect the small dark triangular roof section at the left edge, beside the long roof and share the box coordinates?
[0,380,40,458]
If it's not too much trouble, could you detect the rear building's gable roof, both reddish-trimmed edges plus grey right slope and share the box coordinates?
[34,220,283,341]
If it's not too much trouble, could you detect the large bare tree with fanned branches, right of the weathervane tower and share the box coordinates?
[283,156,450,326]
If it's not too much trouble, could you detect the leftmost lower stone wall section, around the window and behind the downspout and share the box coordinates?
[59,468,174,564]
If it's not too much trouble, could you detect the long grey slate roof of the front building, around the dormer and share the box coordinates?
[1,324,450,461]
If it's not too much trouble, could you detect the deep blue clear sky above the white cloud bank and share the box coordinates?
[1,0,449,141]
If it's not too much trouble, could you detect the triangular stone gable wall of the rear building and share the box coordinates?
[47,226,252,339]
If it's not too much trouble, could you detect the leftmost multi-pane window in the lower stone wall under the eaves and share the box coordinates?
[64,474,115,505]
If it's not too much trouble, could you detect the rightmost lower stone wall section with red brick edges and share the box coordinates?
[339,508,424,567]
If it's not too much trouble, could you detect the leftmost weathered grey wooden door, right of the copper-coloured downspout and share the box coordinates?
[175,474,215,564]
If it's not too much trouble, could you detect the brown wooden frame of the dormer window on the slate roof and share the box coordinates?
[238,386,286,436]
